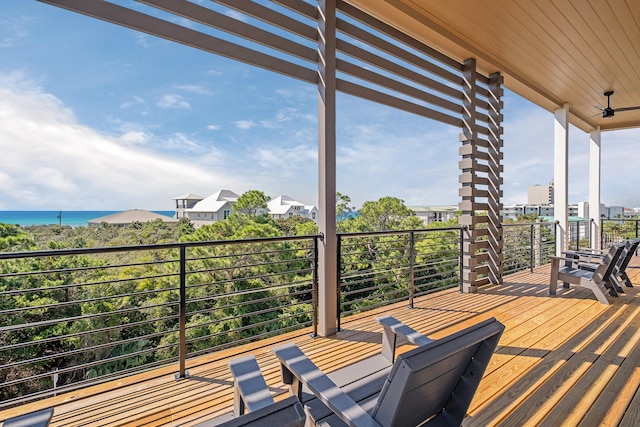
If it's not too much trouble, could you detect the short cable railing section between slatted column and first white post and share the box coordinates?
[502,222,556,274]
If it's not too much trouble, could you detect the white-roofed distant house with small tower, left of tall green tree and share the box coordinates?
[175,190,240,227]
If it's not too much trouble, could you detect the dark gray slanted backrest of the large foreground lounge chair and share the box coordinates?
[371,319,504,427]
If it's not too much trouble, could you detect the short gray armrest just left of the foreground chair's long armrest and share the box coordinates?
[229,355,274,417]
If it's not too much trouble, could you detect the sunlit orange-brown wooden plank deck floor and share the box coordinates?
[0,258,640,427]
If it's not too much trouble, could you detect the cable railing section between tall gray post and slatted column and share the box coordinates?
[338,227,462,327]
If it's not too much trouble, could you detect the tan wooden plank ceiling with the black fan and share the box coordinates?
[348,0,640,132]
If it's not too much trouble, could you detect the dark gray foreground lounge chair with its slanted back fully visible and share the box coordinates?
[274,319,504,427]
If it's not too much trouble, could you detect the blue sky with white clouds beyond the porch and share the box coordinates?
[0,0,640,210]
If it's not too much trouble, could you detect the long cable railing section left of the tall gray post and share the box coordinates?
[0,236,319,408]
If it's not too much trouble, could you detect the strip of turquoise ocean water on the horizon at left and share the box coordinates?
[0,211,175,227]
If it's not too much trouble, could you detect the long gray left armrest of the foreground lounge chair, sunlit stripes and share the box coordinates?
[273,344,380,427]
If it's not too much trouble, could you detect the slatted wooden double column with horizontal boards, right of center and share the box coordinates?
[459,59,502,292]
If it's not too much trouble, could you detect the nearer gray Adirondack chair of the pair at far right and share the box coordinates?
[549,243,624,304]
